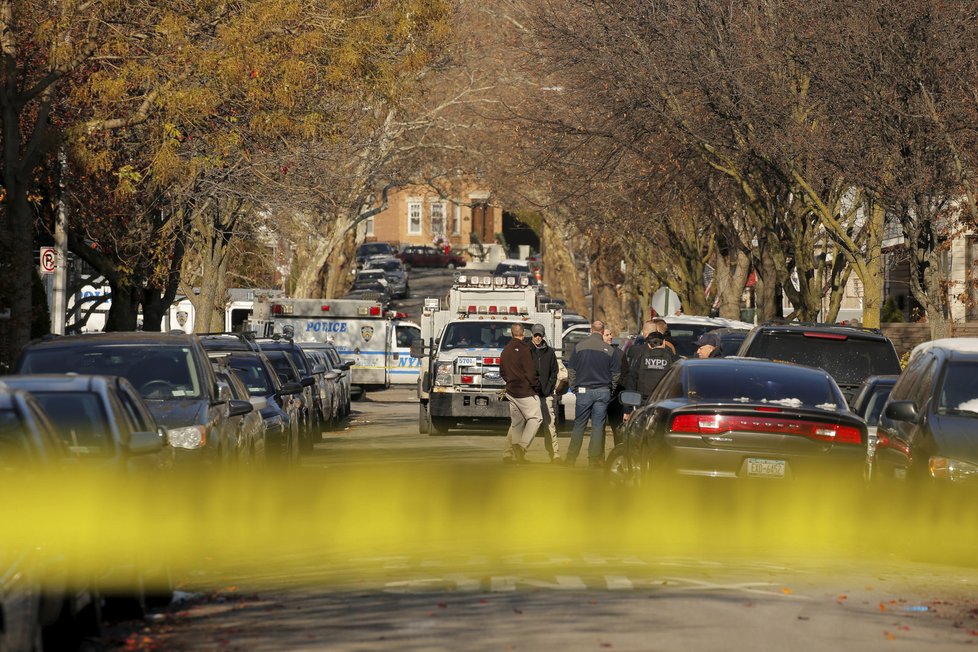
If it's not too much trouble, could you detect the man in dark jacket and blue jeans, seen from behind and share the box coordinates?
[565,321,621,468]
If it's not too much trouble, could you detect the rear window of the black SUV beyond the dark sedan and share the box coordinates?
[749,333,900,386]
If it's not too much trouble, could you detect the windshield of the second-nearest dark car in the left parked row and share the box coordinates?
[32,392,113,456]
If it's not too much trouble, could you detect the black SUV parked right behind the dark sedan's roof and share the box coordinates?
[737,323,900,404]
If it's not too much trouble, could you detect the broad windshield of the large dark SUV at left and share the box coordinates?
[19,342,203,400]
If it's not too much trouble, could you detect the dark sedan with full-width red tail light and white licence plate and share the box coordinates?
[609,358,866,486]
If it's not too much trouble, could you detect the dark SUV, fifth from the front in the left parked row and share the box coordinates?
[221,351,303,464]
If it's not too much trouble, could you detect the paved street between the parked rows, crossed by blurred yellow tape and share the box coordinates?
[101,382,978,650]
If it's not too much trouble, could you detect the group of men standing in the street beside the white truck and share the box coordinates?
[500,319,720,469]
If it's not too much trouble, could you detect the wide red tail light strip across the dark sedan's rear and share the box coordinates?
[670,414,863,445]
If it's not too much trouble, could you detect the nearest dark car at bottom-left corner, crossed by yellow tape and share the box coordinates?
[0,386,102,650]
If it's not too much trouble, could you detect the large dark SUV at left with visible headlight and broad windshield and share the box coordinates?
[15,332,242,464]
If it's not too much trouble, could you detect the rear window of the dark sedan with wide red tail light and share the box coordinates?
[686,360,846,410]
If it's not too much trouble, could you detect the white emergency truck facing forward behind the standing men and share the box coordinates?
[411,274,562,435]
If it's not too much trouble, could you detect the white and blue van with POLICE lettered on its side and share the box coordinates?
[252,299,421,393]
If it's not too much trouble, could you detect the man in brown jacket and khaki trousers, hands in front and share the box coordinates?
[499,324,543,463]
